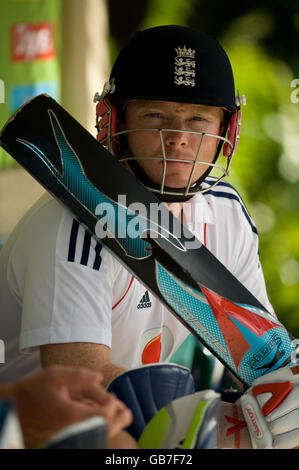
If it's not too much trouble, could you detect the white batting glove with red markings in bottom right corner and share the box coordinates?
[239,365,299,449]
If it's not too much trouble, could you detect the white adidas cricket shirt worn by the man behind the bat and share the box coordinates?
[0,178,273,382]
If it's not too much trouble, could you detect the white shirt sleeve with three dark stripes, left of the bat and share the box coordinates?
[16,202,114,352]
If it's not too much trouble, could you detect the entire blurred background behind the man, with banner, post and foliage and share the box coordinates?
[0,0,299,346]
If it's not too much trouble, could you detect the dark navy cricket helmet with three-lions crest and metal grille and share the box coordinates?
[95,25,245,202]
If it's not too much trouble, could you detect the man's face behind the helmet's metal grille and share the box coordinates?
[121,100,224,188]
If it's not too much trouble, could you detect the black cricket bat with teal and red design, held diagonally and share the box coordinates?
[0,95,295,385]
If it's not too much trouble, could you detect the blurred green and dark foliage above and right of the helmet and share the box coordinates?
[108,0,299,338]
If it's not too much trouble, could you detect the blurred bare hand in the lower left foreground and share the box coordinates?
[11,366,132,448]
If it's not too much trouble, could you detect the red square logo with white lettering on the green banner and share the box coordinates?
[11,22,56,62]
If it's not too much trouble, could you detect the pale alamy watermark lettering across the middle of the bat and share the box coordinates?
[95,194,201,250]
